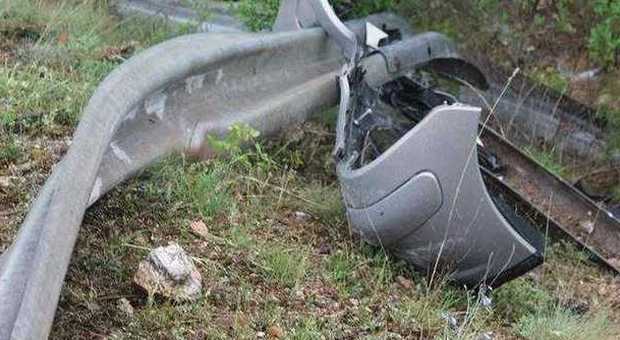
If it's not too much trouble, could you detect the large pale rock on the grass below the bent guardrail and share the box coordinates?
[133,243,202,301]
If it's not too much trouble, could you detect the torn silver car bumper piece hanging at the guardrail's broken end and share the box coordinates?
[337,69,543,287]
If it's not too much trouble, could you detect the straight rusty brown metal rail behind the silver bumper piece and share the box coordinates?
[481,128,620,272]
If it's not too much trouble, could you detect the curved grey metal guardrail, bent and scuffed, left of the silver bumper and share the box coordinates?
[0,9,428,339]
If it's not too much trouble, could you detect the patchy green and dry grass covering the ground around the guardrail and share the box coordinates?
[0,0,619,339]
